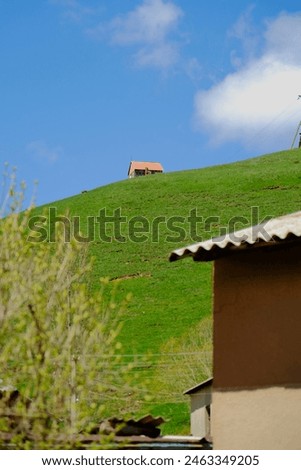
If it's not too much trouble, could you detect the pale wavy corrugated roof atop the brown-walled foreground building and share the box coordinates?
[169,211,301,261]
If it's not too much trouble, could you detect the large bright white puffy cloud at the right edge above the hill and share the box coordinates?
[195,13,301,151]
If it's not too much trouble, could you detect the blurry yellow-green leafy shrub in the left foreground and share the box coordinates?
[0,179,134,449]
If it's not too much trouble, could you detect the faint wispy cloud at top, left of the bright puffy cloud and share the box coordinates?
[87,0,183,69]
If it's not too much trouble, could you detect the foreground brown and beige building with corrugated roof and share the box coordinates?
[170,212,301,449]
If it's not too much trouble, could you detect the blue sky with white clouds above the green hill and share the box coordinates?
[0,0,301,204]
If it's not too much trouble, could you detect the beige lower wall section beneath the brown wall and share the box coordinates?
[211,387,301,450]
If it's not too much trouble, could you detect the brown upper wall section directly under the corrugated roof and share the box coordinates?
[214,245,301,388]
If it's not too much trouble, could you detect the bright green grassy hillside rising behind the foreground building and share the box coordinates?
[37,150,301,433]
